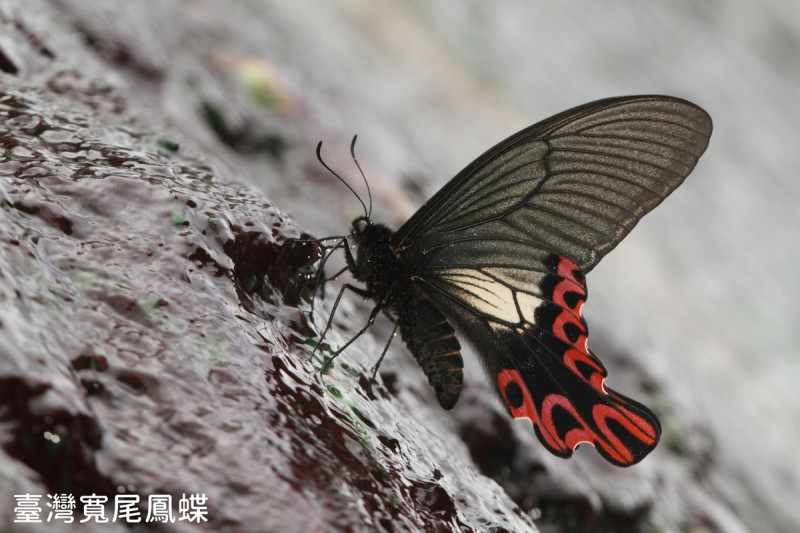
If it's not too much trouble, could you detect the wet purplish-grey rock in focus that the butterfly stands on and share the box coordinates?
[0,2,531,531]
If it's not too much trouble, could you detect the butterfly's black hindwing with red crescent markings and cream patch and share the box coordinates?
[418,241,660,466]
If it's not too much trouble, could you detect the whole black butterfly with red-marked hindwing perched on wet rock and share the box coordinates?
[310,96,712,466]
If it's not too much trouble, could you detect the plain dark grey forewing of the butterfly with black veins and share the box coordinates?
[394,96,711,272]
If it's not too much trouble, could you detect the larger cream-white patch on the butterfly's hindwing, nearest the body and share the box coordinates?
[440,269,521,324]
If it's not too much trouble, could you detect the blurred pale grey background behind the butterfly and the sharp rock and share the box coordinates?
[6,0,800,532]
